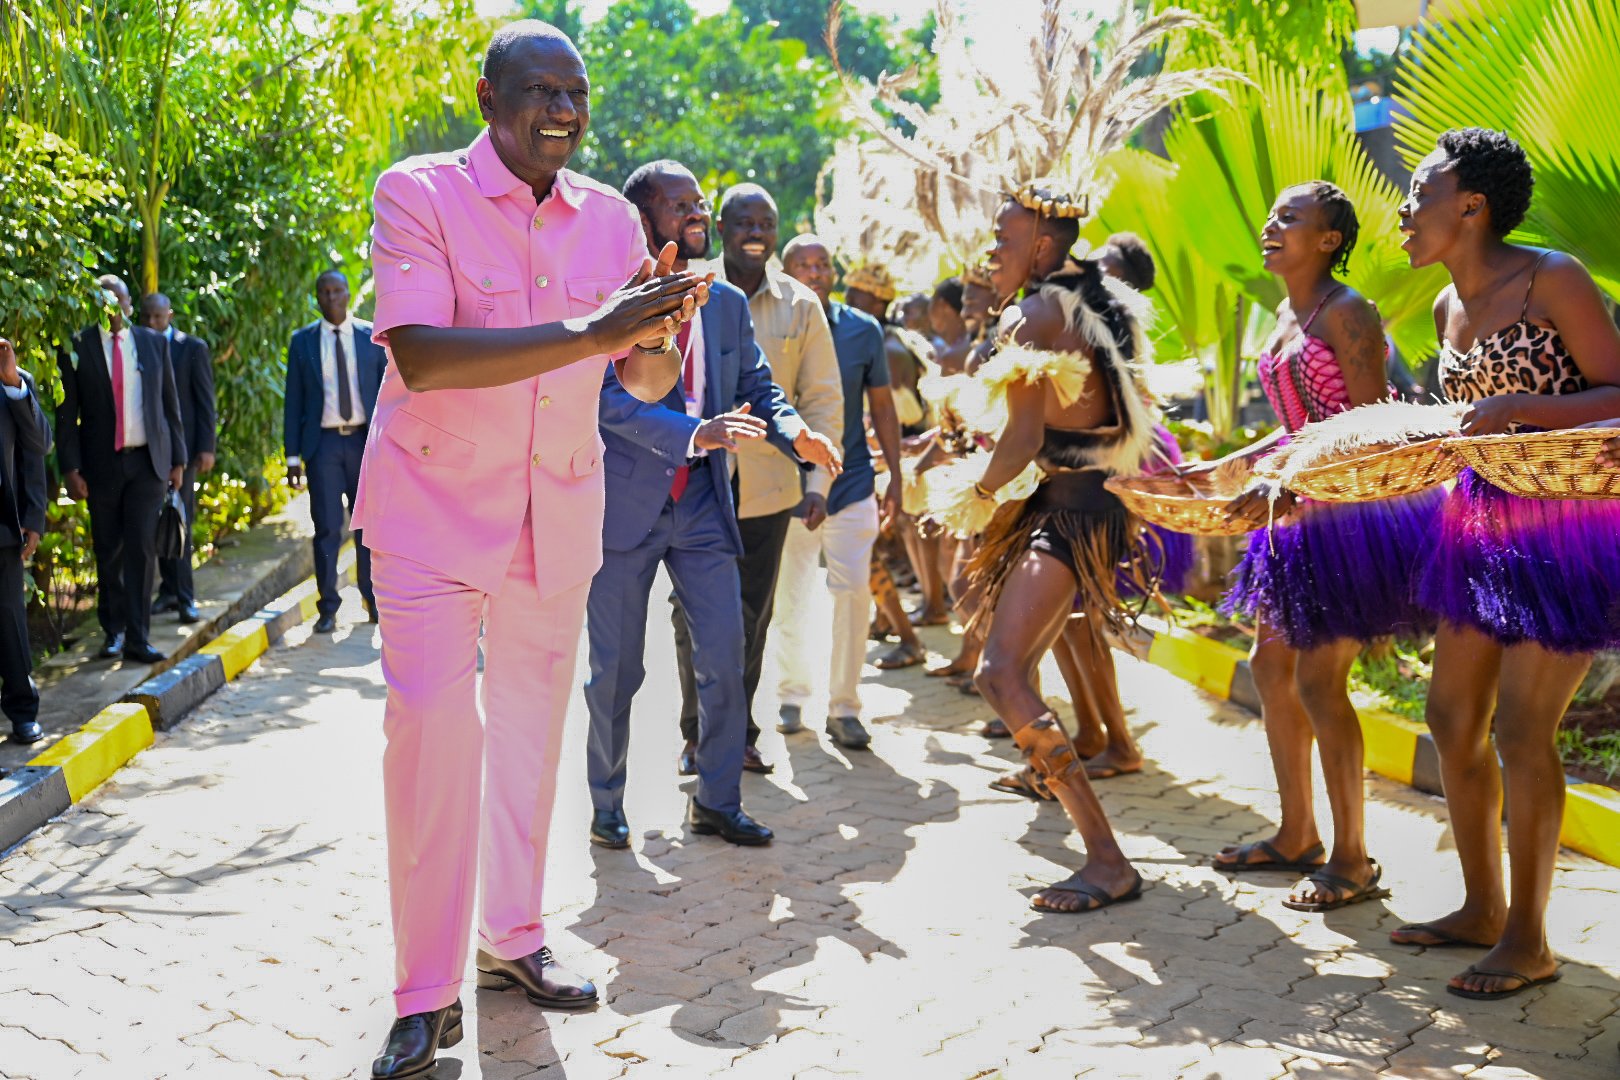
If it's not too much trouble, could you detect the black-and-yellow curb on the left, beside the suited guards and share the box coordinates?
[0,544,355,853]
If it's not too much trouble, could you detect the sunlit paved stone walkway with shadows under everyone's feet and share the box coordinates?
[0,579,1620,1080]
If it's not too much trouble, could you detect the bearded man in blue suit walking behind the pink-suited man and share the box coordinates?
[585,160,839,848]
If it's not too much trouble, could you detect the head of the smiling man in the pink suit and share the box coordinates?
[478,37,591,186]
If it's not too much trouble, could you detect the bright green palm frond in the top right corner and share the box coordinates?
[1396,0,1620,296]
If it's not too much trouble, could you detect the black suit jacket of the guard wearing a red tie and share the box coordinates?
[57,327,190,487]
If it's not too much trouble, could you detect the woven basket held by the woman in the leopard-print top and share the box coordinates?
[1445,427,1620,499]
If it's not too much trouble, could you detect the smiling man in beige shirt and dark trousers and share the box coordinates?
[676,183,844,776]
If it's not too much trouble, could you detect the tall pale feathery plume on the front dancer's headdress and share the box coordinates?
[826,0,1243,244]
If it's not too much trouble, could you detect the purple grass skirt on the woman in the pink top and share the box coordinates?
[1220,487,1445,649]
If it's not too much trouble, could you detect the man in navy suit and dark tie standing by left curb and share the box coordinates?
[285,270,387,633]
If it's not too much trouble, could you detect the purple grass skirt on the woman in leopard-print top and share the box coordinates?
[1418,470,1620,653]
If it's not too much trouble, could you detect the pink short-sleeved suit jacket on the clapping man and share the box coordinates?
[353,131,646,597]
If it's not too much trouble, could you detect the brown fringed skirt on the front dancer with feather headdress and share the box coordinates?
[967,470,1157,630]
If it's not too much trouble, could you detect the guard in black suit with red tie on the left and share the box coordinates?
[57,274,186,664]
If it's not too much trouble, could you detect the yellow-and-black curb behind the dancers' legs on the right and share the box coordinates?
[1136,617,1620,866]
